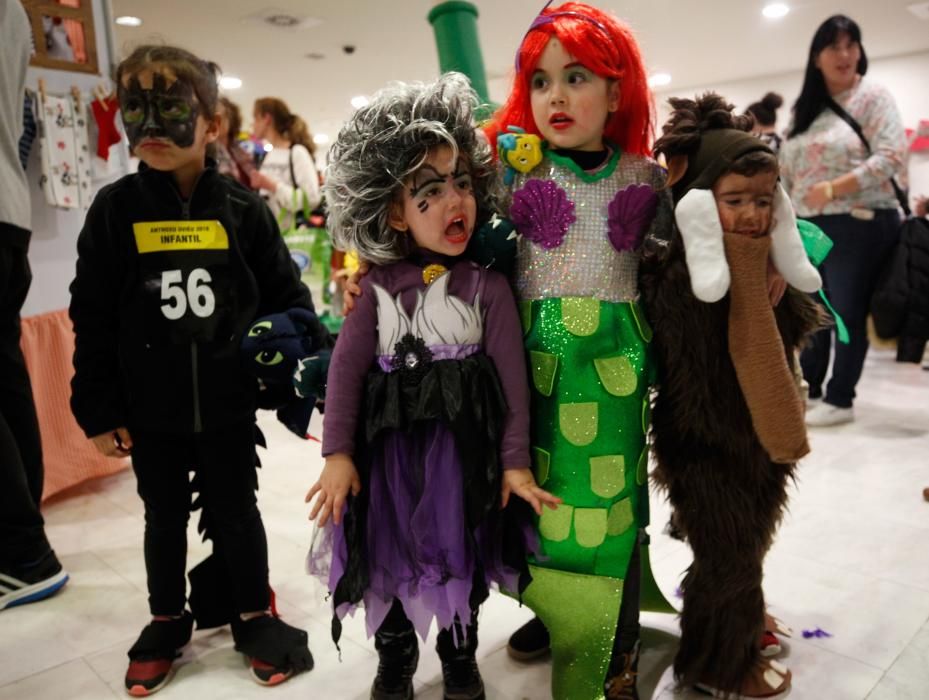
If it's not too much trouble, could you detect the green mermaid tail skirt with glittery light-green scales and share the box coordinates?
[520,297,674,700]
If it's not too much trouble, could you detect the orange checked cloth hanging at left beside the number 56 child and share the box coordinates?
[22,309,129,499]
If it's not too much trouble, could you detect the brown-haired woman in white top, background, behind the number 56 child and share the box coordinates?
[251,97,322,231]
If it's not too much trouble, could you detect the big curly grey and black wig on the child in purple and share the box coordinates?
[323,73,500,265]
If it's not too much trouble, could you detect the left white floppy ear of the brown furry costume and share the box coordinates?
[674,189,729,303]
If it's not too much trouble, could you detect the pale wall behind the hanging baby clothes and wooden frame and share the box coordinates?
[22,0,129,316]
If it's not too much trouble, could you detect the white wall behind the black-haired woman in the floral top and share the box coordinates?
[656,52,929,205]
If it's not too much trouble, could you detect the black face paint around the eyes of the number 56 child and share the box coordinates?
[118,73,199,148]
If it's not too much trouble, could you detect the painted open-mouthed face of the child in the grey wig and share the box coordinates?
[390,146,477,256]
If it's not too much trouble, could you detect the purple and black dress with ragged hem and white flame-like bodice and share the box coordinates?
[309,255,532,641]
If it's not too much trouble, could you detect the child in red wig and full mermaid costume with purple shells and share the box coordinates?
[487,3,672,699]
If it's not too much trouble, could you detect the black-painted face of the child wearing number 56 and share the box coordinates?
[119,66,215,170]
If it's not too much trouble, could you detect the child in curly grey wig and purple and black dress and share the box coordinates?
[307,74,558,700]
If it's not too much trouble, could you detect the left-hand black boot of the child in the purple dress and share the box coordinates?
[371,602,419,700]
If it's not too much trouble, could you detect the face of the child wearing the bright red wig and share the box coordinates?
[530,37,619,151]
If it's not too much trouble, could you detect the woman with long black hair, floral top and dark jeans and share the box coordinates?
[780,15,906,426]
